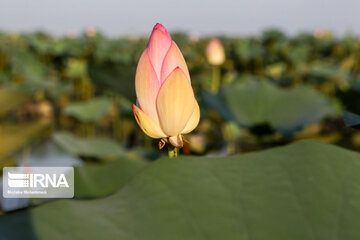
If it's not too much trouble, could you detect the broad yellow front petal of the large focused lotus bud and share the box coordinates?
[156,68,195,136]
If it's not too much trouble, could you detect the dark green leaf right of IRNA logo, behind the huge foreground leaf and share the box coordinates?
[74,156,148,198]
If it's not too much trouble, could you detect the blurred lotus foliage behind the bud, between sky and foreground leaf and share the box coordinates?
[0,29,360,154]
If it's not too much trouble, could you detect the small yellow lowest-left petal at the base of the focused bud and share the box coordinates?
[133,104,166,138]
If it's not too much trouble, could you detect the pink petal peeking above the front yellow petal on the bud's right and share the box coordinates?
[160,41,190,82]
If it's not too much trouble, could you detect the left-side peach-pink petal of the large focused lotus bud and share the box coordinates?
[135,50,160,123]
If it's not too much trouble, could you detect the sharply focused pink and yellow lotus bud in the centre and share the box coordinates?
[133,23,200,148]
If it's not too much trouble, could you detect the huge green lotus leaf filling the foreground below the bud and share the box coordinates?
[0,141,360,240]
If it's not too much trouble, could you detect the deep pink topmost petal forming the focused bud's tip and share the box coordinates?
[147,23,172,79]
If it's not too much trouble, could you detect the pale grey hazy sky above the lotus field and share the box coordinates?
[0,0,360,36]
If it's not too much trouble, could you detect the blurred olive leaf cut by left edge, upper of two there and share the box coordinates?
[0,89,31,117]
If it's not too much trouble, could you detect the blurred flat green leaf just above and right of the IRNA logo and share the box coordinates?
[53,131,124,159]
